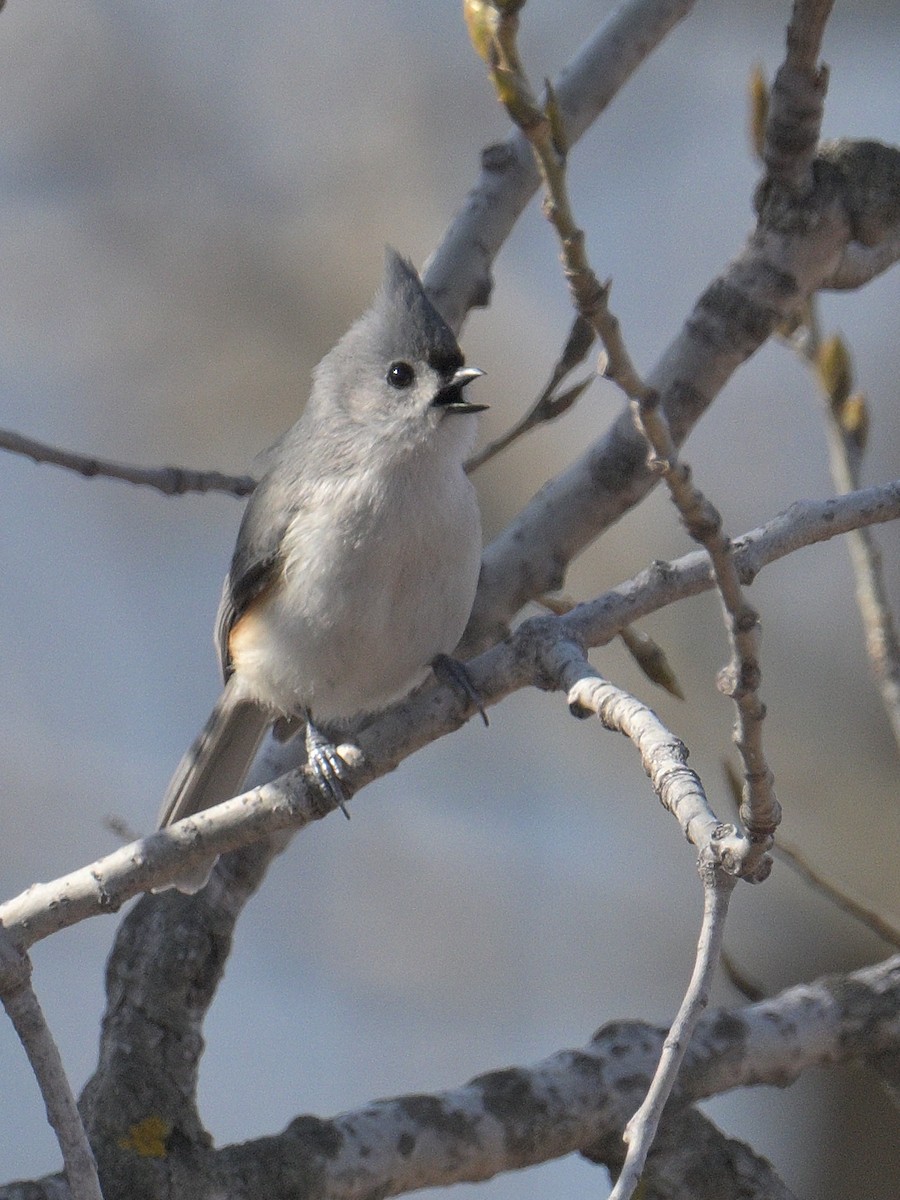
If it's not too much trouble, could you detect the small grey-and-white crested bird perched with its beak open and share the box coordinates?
[160,250,487,892]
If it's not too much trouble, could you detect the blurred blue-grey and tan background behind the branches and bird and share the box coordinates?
[0,0,900,1200]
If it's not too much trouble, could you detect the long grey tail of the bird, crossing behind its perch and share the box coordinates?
[160,680,271,893]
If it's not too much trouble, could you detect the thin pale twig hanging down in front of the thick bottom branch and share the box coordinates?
[610,863,737,1200]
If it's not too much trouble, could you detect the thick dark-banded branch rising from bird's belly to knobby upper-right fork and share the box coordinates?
[464,141,864,649]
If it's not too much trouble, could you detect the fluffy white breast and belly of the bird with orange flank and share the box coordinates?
[230,436,481,724]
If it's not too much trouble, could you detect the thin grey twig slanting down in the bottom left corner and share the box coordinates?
[0,925,103,1200]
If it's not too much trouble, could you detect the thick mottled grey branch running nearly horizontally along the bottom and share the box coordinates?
[0,958,900,1200]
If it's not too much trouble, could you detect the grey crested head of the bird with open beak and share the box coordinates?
[307,248,486,440]
